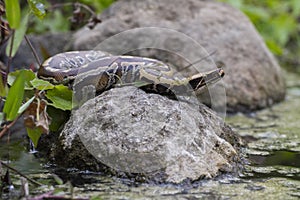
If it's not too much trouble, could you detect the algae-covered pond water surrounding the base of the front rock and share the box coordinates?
[0,71,300,200]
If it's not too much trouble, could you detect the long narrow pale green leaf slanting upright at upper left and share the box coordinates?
[6,15,28,57]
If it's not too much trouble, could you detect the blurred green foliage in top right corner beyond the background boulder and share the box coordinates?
[219,0,300,68]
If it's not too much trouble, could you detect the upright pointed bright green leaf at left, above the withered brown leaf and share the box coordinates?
[3,71,25,121]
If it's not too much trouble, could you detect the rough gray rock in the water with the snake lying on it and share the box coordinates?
[53,87,241,183]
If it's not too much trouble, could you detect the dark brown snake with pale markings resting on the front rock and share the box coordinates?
[38,51,224,95]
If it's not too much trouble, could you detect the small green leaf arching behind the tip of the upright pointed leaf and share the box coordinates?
[7,69,35,90]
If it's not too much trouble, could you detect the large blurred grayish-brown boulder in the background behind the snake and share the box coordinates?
[74,0,285,112]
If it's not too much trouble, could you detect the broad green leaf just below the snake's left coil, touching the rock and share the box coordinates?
[46,85,72,110]
